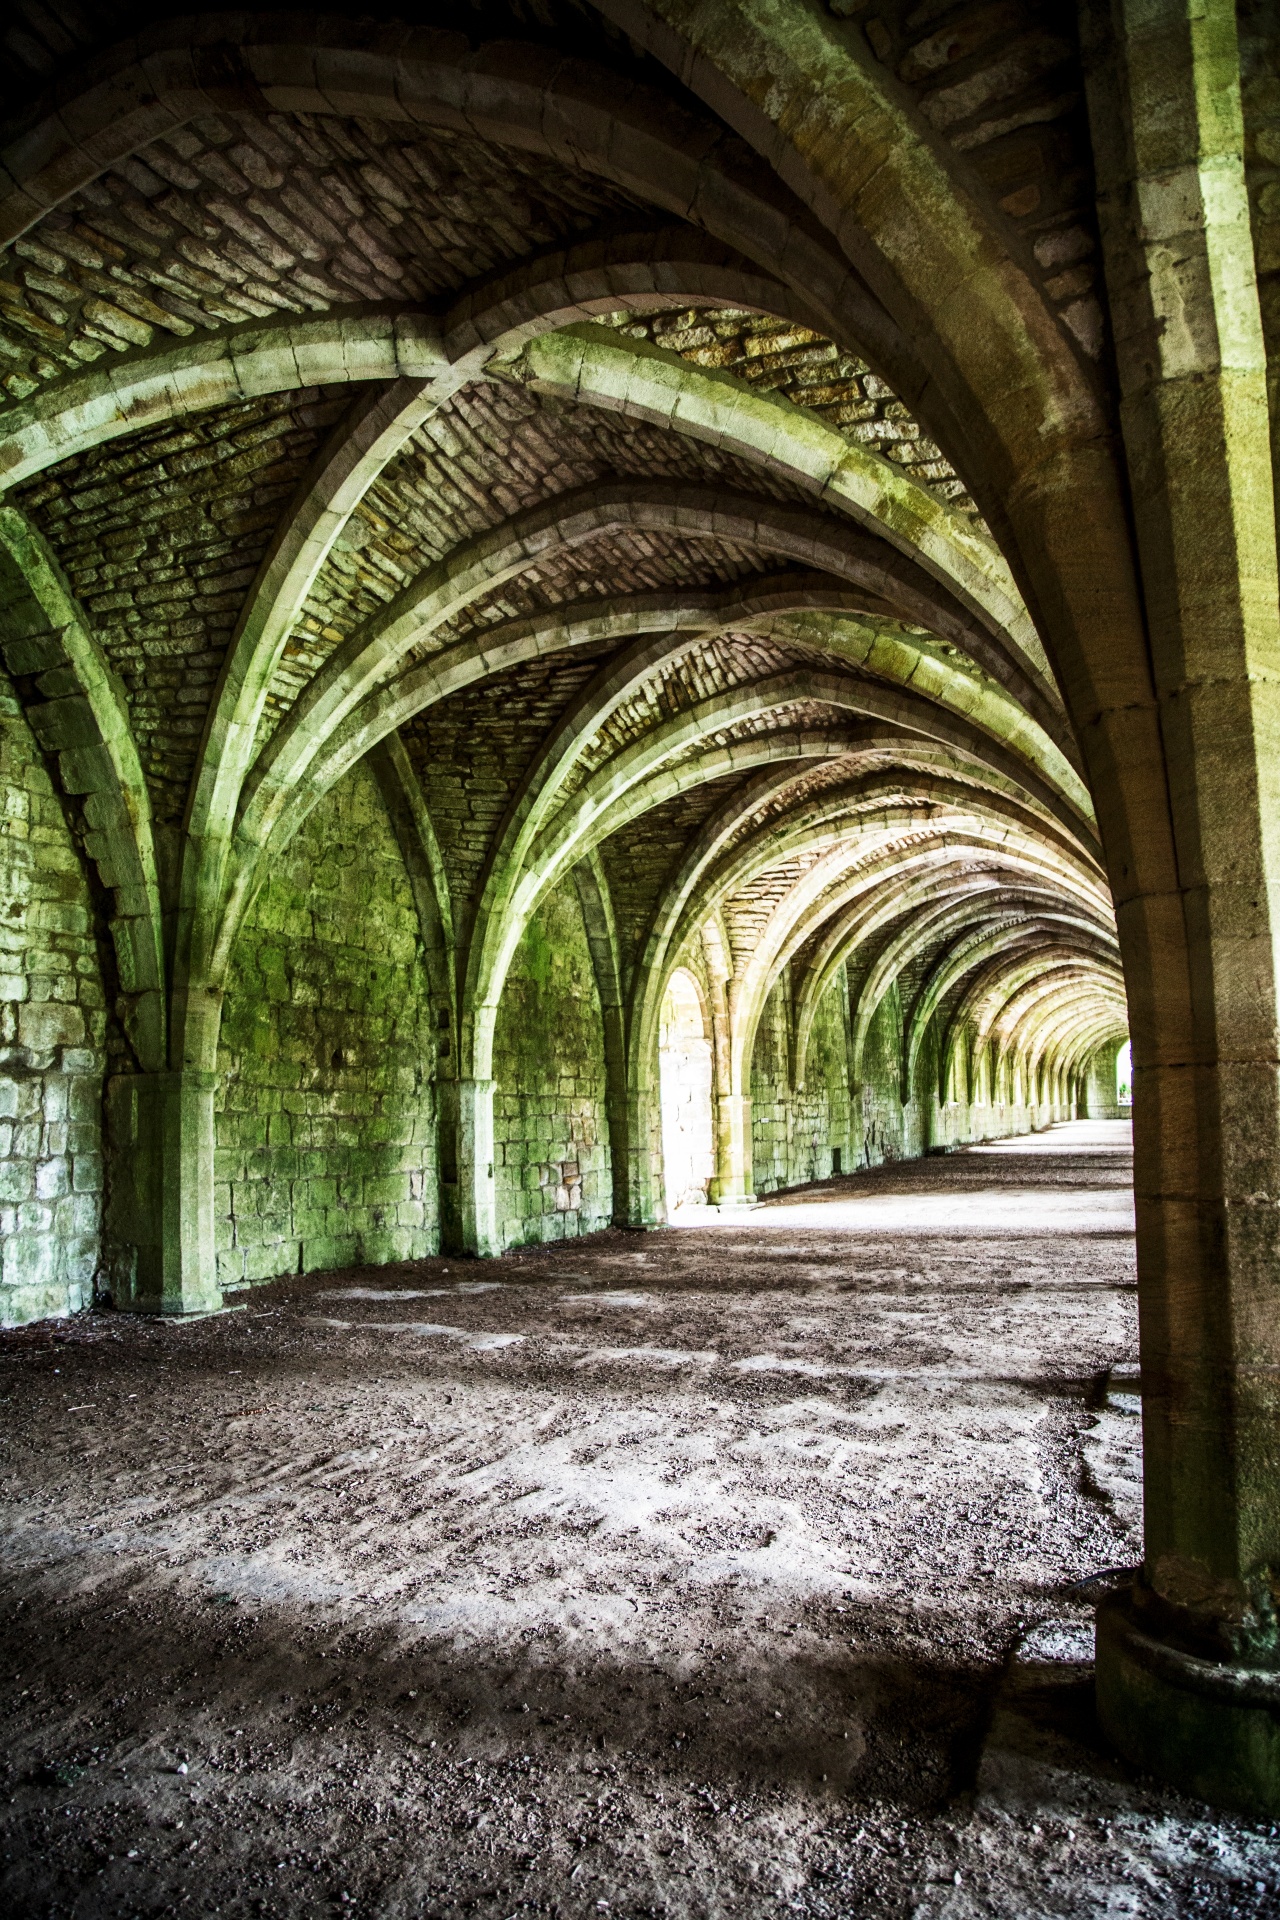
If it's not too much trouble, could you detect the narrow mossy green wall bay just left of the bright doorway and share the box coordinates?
[493,887,612,1246]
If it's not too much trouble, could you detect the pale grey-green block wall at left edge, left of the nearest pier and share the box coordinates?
[0,676,106,1325]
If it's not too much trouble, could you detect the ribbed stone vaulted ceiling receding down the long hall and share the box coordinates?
[0,4,1125,1251]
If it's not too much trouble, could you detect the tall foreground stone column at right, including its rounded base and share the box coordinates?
[1088,0,1280,1816]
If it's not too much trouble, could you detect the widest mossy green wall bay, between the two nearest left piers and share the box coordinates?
[215,766,439,1288]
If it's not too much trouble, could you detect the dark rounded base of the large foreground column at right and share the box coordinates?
[1096,1594,1280,1820]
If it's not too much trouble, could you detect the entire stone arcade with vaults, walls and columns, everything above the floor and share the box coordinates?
[0,0,1280,1835]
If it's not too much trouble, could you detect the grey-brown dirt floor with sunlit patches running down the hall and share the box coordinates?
[0,1125,1280,1920]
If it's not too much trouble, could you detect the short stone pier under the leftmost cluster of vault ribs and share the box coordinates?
[107,1068,223,1313]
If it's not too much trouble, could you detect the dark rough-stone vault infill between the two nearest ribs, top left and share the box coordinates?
[0,113,631,399]
